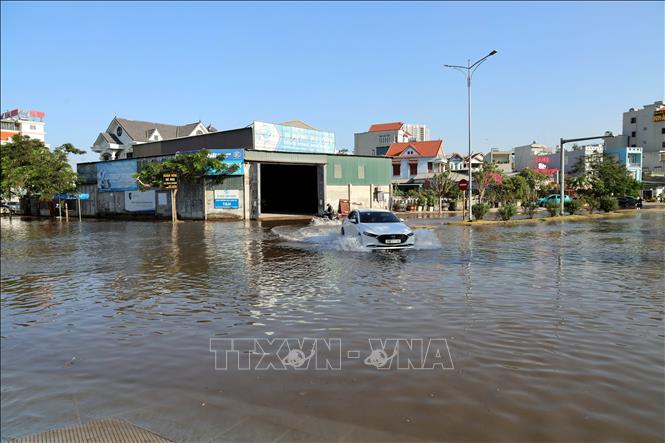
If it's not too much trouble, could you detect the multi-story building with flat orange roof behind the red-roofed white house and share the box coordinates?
[354,122,429,156]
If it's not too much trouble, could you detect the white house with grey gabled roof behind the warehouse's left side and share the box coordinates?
[92,117,216,160]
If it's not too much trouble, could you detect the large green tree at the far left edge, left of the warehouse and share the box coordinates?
[0,135,85,199]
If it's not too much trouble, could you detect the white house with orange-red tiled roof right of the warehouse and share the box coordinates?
[386,140,446,185]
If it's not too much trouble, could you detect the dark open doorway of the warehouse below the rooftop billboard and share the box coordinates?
[260,163,319,215]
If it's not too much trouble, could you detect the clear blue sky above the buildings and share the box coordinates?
[0,1,665,165]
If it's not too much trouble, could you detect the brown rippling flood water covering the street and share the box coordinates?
[1,211,665,442]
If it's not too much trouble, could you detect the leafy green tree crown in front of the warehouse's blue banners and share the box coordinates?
[135,149,238,189]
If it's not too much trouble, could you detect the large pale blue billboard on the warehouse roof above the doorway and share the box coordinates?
[254,122,335,154]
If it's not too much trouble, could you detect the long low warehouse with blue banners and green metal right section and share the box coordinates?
[78,121,391,220]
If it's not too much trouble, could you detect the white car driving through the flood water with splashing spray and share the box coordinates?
[342,209,416,249]
